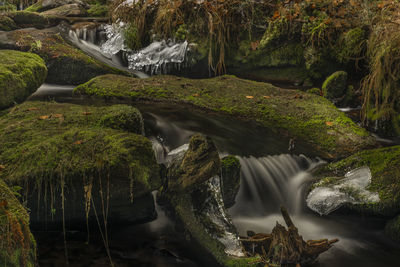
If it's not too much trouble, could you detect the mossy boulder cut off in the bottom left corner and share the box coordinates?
[0,180,37,267]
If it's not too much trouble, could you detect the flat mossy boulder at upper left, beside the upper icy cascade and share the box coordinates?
[0,28,125,84]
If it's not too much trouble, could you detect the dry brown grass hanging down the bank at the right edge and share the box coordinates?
[362,1,400,133]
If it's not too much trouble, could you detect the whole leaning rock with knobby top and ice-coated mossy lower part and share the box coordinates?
[163,135,249,266]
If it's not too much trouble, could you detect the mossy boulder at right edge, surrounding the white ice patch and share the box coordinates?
[316,146,400,218]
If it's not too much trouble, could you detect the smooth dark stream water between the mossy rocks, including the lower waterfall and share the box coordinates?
[30,84,400,267]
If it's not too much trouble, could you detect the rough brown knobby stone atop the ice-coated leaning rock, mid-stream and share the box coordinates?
[167,135,220,192]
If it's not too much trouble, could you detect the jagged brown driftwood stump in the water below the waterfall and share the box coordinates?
[240,207,339,267]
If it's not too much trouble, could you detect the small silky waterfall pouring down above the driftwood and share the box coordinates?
[231,154,322,216]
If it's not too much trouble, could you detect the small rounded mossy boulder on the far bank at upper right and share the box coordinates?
[322,71,347,99]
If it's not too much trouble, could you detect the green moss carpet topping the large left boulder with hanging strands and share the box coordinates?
[0,102,161,196]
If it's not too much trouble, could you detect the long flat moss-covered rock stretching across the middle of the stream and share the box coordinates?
[75,75,375,158]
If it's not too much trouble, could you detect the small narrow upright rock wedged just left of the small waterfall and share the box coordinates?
[221,156,240,208]
